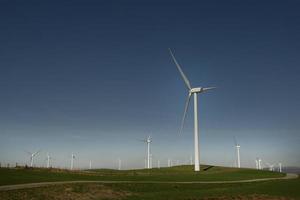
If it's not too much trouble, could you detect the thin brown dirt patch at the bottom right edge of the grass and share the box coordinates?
[202,194,294,200]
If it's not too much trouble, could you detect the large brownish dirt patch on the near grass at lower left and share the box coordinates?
[0,184,130,200]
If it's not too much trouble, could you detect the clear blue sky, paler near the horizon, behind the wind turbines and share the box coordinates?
[0,0,300,168]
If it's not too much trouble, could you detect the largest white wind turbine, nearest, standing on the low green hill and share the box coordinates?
[169,49,215,171]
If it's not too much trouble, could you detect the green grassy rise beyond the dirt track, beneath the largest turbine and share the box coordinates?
[0,166,284,185]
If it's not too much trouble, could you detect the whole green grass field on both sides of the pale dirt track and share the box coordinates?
[0,166,300,200]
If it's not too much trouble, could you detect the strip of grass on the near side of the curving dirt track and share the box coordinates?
[0,178,300,200]
